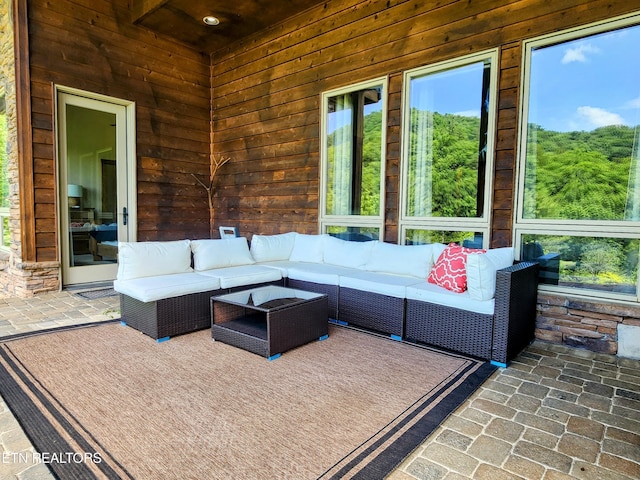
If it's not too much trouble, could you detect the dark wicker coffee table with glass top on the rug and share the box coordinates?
[211,286,329,360]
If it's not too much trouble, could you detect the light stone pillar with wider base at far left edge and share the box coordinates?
[0,0,60,297]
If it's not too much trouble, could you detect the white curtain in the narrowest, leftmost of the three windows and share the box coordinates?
[327,94,353,215]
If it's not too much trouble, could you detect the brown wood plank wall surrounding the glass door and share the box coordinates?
[28,0,210,261]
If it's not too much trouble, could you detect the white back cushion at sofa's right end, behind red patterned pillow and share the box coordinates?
[467,247,514,300]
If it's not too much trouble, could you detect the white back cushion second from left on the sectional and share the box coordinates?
[191,237,255,272]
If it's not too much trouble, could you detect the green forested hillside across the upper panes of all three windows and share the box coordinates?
[328,110,640,226]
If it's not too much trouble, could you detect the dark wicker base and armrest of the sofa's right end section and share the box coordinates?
[405,262,538,365]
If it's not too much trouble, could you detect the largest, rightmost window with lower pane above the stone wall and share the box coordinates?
[514,16,640,301]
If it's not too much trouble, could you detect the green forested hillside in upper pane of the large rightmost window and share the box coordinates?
[525,125,640,220]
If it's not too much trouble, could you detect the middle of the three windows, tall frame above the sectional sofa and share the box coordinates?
[400,51,497,247]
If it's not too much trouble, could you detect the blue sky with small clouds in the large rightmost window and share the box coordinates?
[529,26,640,132]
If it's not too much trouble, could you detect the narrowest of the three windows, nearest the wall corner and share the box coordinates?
[320,79,387,240]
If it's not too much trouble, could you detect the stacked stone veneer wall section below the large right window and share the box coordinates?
[536,294,640,355]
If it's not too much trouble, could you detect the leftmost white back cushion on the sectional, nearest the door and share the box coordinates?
[118,240,193,280]
